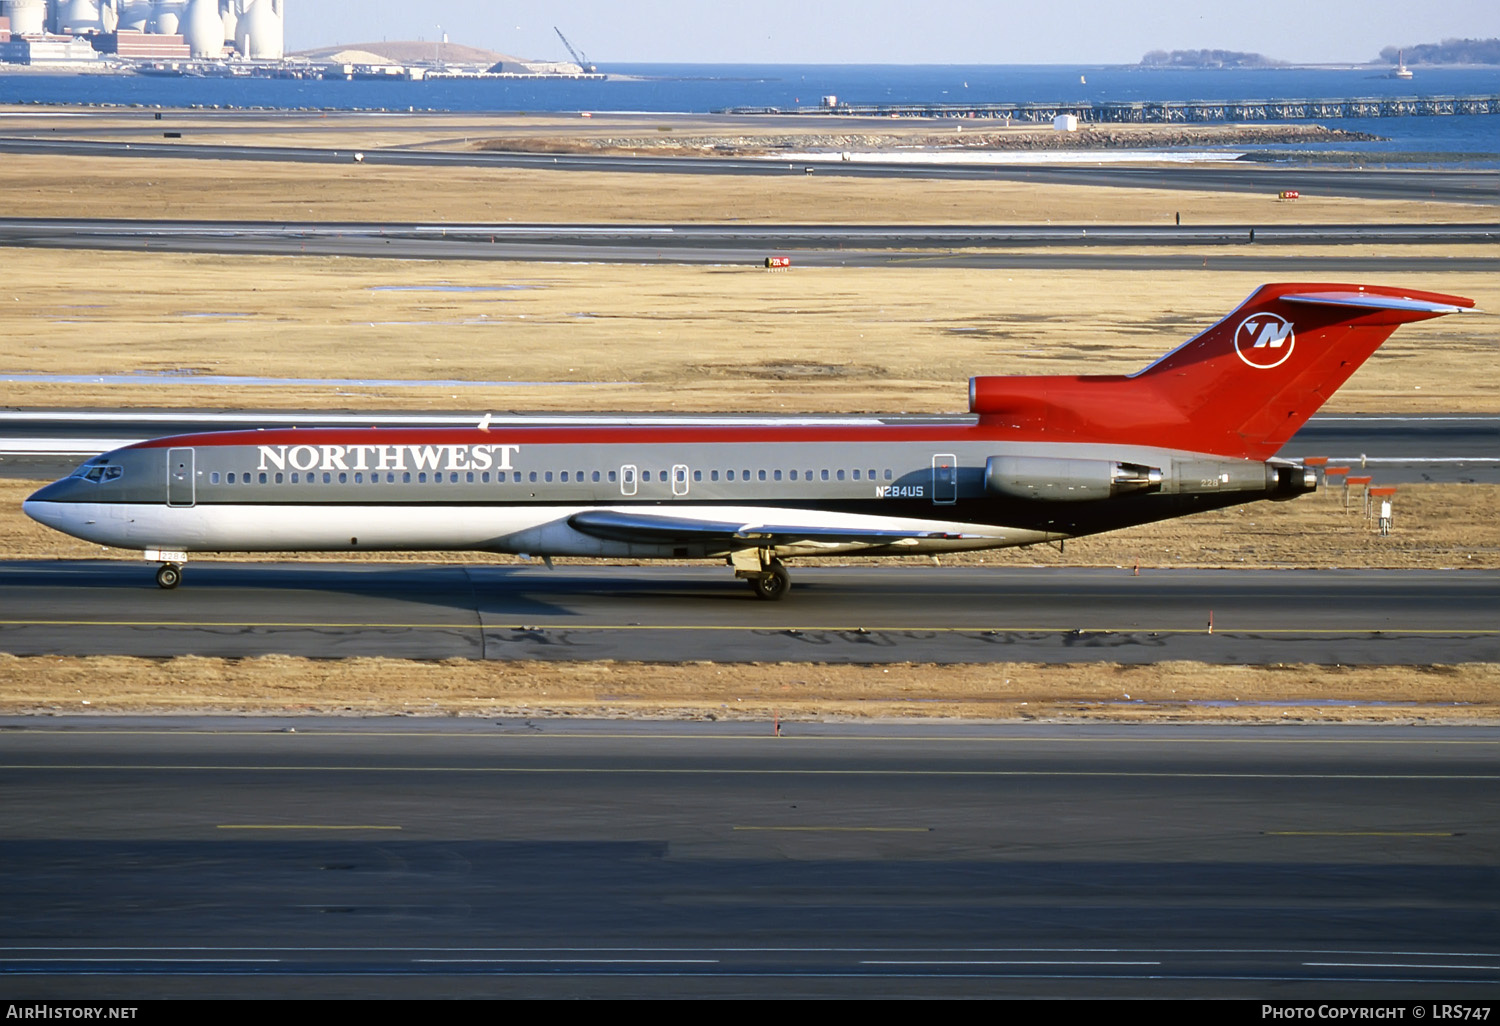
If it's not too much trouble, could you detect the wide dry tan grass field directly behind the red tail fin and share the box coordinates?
[0,251,1500,413]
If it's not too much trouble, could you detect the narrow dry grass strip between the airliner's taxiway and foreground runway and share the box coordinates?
[0,654,1500,720]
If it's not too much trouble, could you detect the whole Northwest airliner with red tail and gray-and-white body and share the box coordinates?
[24,284,1473,599]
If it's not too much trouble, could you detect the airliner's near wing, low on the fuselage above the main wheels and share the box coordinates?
[567,510,978,549]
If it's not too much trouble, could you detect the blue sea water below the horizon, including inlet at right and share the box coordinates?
[0,65,1500,165]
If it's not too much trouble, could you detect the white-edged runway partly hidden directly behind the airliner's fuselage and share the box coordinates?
[0,408,1500,485]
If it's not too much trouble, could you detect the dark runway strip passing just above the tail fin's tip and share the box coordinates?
[0,218,1500,275]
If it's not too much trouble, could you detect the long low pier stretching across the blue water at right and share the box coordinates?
[717,96,1500,125]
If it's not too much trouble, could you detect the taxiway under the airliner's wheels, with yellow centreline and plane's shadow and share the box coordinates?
[0,557,1500,666]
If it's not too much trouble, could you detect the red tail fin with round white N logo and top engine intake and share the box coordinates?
[971,284,1473,459]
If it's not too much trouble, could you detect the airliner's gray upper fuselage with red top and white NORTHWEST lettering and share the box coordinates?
[20,422,1290,534]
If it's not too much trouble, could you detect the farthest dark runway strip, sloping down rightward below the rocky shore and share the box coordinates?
[0,134,1500,204]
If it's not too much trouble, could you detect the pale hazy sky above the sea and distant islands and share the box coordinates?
[285,0,1500,69]
